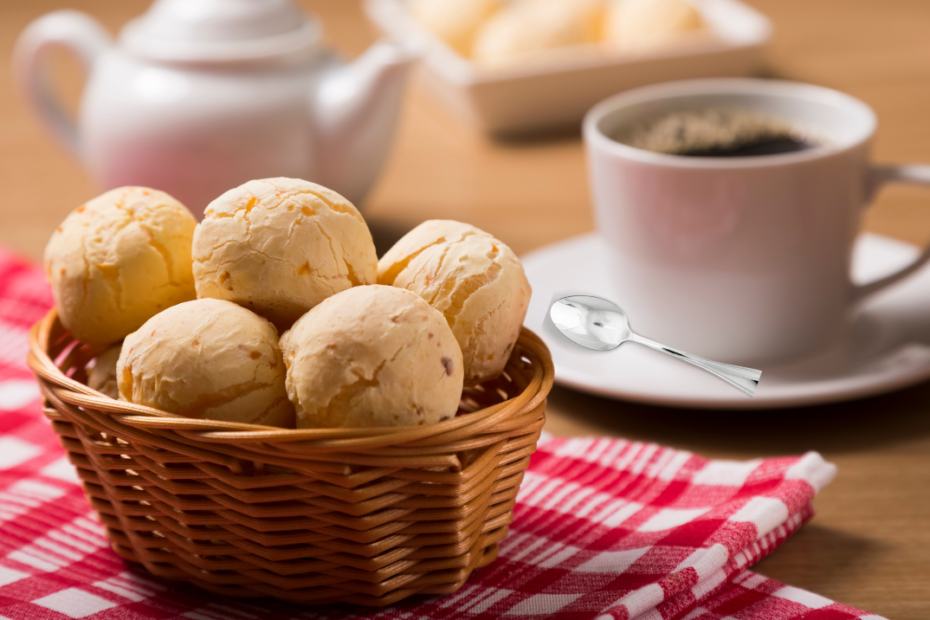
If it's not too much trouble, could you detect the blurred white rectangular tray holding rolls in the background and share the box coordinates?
[365,0,772,135]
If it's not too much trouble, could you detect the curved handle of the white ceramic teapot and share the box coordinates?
[13,10,112,159]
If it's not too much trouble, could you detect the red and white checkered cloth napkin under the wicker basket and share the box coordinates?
[0,252,878,620]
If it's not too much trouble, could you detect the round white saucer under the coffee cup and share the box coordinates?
[522,233,930,409]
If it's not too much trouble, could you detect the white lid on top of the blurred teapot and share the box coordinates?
[120,0,320,62]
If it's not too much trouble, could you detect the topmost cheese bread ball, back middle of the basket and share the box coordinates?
[193,178,378,330]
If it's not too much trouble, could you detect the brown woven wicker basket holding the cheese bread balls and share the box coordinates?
[29,310,553,606]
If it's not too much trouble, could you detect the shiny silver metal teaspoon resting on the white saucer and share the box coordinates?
[549,295,762,396]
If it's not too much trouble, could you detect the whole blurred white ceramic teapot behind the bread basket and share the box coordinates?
[14,0,413,217]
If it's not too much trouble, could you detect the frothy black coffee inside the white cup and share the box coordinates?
[612,108,821,157]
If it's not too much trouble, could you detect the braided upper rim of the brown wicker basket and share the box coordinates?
[26,308,555,449]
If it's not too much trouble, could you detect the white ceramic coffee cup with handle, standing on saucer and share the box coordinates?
[584,79,930,364]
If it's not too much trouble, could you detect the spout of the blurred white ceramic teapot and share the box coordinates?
[314,41,416,203]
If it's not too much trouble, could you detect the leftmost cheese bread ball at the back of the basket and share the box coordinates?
[45,187,197,345]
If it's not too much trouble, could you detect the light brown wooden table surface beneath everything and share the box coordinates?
[0,0,930,620]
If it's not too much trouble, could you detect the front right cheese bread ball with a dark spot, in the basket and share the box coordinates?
[281,285,463,428]
